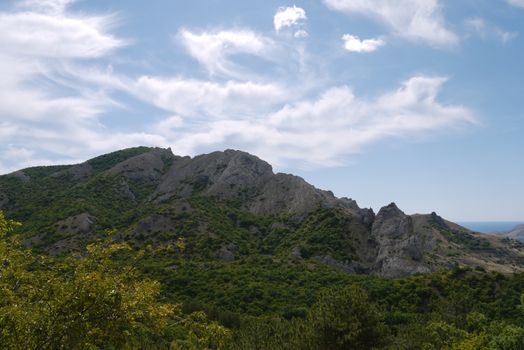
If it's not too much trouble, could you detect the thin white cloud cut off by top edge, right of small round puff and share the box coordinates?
[323,0,459,46]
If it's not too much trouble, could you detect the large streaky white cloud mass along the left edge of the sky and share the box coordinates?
[0,0,131,169]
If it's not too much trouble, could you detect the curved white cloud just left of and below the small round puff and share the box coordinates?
[177,29,273,76]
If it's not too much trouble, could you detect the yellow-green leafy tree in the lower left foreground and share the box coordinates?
[0,212,228,349]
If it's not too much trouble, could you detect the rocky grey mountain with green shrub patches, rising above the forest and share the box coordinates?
[0,147,524,277]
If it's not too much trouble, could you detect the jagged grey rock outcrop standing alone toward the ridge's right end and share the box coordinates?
[371,203,431,277]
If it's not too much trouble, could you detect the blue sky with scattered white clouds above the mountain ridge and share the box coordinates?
[0,0,524,221]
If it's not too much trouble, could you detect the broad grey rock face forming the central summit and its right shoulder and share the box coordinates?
[151,150,374,220]
